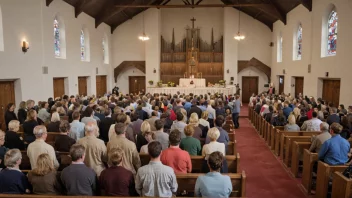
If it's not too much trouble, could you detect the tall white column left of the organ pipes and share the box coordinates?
[144,8,161,86]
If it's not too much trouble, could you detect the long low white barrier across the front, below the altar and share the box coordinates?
[147,86,236,95]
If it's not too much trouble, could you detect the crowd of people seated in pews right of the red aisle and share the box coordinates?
[249,93,352,165]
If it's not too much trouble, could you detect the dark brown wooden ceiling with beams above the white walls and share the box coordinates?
[46,0,312,32]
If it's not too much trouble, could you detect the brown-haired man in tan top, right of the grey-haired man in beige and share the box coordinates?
[107,122,141,175]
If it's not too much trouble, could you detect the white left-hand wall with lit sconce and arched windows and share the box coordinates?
[0,0,113,103]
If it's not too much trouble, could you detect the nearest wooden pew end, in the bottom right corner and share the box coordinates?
[331,171,352,198]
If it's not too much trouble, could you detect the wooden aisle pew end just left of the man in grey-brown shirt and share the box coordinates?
[290,141,312,177]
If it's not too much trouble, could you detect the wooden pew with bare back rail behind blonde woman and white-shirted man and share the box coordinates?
[275,129,321,156]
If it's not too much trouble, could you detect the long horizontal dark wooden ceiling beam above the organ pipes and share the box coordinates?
[115,3,271,8]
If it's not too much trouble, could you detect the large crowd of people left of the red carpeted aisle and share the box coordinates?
[0,94,241,197]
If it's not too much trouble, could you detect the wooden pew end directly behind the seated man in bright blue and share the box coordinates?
[316,161,348,198]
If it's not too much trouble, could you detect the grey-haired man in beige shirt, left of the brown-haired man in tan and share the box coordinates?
[77,122,107,176]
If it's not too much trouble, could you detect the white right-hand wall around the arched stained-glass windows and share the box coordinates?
[272,0,352,105]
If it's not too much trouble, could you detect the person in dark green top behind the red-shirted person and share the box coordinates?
[180,124,201,156]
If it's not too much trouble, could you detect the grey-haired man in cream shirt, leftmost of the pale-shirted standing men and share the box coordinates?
[27,125,59,170]
